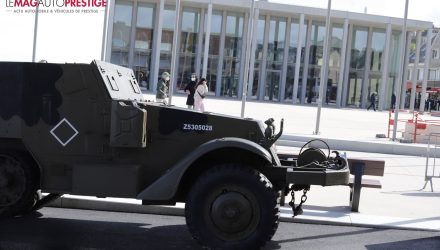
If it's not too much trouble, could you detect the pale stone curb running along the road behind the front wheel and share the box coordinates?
[47,197,440,232]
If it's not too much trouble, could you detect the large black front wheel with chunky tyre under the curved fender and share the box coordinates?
[185,164,279,249]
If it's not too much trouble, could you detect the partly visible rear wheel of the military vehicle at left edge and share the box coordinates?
[0,152,38,217]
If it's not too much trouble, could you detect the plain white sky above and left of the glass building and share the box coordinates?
[0,0,440,63]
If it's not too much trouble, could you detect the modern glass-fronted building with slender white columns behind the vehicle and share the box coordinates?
[105,0,433,109]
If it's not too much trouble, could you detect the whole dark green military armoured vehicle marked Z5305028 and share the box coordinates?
[0,61,349,249]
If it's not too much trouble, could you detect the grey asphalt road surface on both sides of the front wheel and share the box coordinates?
[0,208,440,250]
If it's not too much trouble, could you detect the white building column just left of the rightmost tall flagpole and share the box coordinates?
[378,23,392,111]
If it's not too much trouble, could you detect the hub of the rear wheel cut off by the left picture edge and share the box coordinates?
[0,156,26,206]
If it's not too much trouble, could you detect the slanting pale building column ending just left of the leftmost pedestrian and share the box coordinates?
[150,0,165,92]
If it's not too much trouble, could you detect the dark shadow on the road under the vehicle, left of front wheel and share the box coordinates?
[0,212,200,250]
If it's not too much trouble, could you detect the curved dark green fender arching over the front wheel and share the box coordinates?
[137,137,272,201]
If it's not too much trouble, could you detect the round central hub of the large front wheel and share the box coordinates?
[211,192,252,234]
